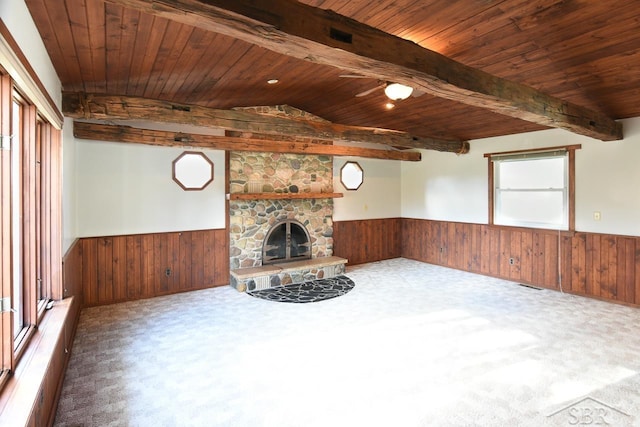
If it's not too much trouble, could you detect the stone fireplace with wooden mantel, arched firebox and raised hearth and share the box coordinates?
[229,152,347,291]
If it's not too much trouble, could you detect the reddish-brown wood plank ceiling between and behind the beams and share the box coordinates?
[26,0,640,144]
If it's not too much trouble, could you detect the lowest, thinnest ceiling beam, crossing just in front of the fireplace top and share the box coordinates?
[73,121,422,162]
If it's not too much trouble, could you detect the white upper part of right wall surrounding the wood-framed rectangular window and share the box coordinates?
[401,118,640,236]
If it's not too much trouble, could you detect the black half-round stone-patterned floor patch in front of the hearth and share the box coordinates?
[247,276,355,303]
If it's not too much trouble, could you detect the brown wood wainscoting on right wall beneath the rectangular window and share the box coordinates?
[401,218,640,305]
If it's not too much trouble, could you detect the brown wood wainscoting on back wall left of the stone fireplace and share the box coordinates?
[80,229,229,307]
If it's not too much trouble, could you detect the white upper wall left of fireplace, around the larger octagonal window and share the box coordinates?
[76,140,225,237]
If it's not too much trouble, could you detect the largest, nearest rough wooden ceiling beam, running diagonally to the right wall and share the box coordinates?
[107,0,622,141]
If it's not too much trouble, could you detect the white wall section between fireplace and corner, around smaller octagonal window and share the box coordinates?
[333,157,402,221]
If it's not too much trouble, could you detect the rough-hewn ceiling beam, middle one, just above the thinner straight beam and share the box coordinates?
[62,92,469,154]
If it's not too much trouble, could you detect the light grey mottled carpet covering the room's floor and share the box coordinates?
[55,259,640,427]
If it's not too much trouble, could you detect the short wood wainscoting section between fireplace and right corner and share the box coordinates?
[333,218,404,265]
